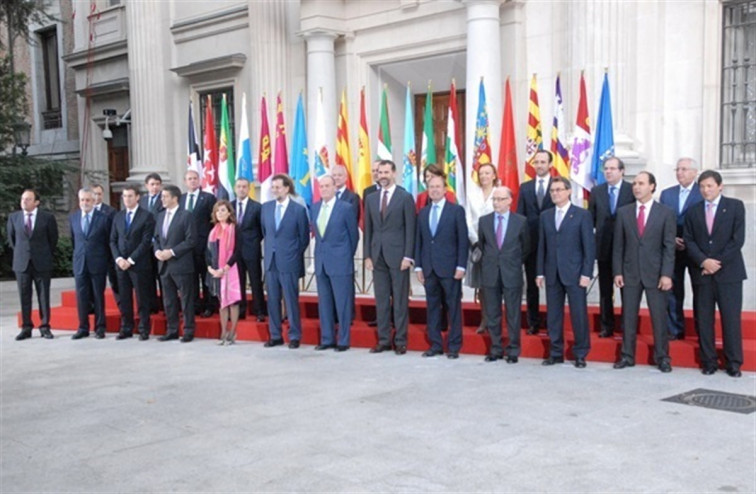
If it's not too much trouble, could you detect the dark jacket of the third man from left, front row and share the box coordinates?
[110,207,155,272]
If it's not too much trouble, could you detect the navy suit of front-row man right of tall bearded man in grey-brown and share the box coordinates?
[415,201,470,354]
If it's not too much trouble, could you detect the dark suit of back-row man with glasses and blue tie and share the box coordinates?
[588,180,635,332]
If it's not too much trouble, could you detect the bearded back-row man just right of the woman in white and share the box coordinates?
[517,151,554,334]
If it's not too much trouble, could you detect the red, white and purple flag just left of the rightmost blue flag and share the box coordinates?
[570,73,593,207]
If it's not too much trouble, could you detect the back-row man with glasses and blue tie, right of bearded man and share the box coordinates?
[588,156,633,338]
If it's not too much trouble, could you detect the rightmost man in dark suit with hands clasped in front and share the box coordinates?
[683,170,746,377]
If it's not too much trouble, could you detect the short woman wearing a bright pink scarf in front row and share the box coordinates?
[207,199,242,345]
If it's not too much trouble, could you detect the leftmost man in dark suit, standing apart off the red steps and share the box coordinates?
[6,189,58,341]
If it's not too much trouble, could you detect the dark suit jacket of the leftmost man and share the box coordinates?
[6,208,58,273]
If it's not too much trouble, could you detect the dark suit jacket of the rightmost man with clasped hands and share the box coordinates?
[683,196,746,285]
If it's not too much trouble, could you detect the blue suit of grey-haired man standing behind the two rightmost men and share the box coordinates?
[659,182,703,336]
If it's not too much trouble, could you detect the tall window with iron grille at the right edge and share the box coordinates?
[720,0,756,168]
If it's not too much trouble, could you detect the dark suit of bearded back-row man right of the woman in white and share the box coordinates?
[517,177,554,328]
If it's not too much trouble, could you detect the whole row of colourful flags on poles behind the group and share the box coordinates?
[187,74,614,208]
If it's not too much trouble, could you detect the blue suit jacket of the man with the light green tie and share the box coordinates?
[312,199,360,276]
